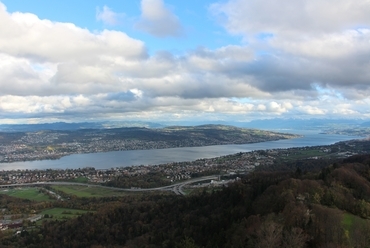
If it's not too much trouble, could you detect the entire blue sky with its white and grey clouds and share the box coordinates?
[0,0,370,124]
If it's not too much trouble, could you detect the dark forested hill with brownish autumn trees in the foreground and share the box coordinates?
[5,155,370,248]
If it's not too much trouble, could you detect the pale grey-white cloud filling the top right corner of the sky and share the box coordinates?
[211,0,370,37]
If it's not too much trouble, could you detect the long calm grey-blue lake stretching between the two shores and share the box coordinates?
[0,130,359,170]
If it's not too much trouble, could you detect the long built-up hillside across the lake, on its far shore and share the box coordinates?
[0,125,298,162]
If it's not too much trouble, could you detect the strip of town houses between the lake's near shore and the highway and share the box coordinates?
[0,139,370,185]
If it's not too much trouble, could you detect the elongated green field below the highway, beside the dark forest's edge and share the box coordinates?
[52,185,132,197]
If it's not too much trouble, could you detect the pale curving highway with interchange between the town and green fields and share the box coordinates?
[0,175,218,195]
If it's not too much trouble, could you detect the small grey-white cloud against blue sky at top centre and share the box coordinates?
[135,0,183,37]
